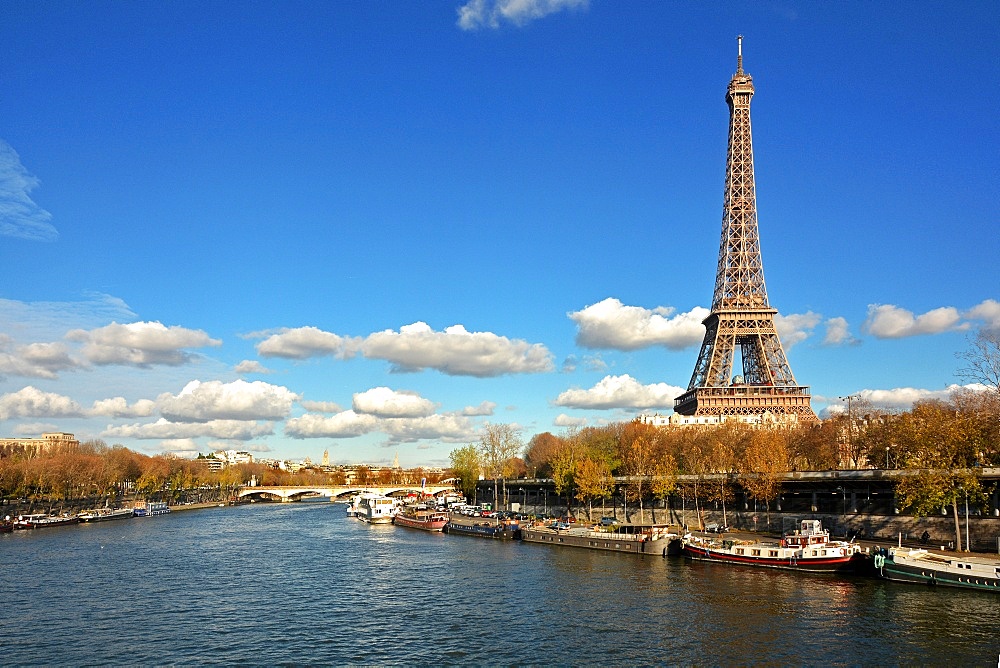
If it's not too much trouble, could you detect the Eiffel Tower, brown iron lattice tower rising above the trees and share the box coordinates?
[674,35,817,423]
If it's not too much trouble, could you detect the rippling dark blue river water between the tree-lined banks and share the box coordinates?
[0,502,1000,667]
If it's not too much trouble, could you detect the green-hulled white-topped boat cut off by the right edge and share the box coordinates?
[871,547,1000,593]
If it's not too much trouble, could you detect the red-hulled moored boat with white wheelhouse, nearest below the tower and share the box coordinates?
[683,520,865,573]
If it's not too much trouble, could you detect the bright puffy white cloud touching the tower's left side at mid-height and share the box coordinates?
[567,297,709,350]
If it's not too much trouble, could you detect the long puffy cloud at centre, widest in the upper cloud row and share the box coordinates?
[361,322,554,378]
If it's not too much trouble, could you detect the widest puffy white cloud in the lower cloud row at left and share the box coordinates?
[156,380,299,422]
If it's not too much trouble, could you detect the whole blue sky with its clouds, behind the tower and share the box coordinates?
[0,0,1000,466]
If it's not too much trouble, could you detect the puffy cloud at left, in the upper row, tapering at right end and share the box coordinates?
[66,322,222,367]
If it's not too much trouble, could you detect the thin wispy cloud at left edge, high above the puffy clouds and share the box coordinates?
[0,139,59,241]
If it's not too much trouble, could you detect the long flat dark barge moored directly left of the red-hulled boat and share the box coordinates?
[521,522,680,556]
